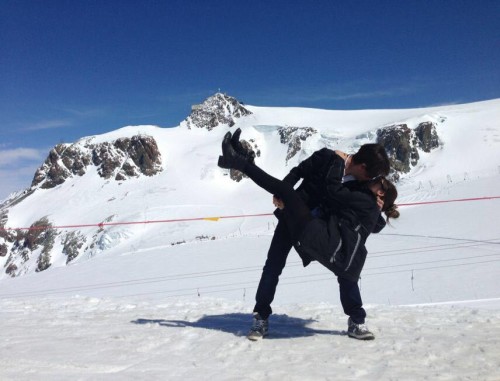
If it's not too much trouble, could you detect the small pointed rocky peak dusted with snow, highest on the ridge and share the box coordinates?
[186,93,252,131]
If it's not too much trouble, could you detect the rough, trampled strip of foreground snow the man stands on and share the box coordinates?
[0,296,500,381]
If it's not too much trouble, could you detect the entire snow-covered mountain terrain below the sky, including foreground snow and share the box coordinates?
[0,94,500,381]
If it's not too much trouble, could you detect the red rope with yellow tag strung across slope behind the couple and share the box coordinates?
[0,196,500,231]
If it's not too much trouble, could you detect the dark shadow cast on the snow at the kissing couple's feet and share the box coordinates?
[131,313,346,339]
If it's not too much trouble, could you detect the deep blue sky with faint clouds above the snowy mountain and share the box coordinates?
[0,0,500,199]
